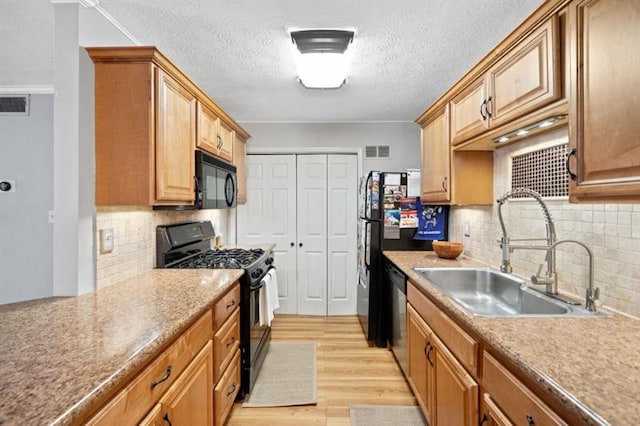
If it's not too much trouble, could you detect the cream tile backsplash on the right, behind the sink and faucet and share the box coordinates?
[449,128,640,317]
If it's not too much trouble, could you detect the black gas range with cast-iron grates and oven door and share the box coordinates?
[156,221,274,397]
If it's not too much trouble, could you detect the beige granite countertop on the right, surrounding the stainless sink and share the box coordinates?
[384,251,640,425]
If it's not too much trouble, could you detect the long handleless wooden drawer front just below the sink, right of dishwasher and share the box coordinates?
[407,282,478,377]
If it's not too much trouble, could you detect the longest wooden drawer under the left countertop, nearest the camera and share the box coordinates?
[87,310,212,425]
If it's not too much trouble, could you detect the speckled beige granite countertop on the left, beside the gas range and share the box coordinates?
[0,269,243,425]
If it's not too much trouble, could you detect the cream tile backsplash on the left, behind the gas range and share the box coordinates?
[96,207,228,288]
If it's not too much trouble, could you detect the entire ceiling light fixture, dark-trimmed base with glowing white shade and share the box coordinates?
[290,30,354,89]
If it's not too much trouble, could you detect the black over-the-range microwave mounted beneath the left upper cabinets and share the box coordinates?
[154,151,237,210]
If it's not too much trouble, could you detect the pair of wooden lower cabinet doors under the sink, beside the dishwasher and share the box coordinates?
[407,304,478,426]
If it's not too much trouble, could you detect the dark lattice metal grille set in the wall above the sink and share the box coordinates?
[511,143,569,198]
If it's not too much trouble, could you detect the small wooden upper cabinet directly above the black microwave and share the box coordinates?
[196,102,234,162]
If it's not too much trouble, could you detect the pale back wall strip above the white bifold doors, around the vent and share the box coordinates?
[241,122,420,174]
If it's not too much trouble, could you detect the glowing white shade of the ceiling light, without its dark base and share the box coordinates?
[296,51,349,89]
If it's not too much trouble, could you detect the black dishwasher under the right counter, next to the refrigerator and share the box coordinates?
[384,261,409,376]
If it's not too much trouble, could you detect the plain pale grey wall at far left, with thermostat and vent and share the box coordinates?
[0,95,53,303]
